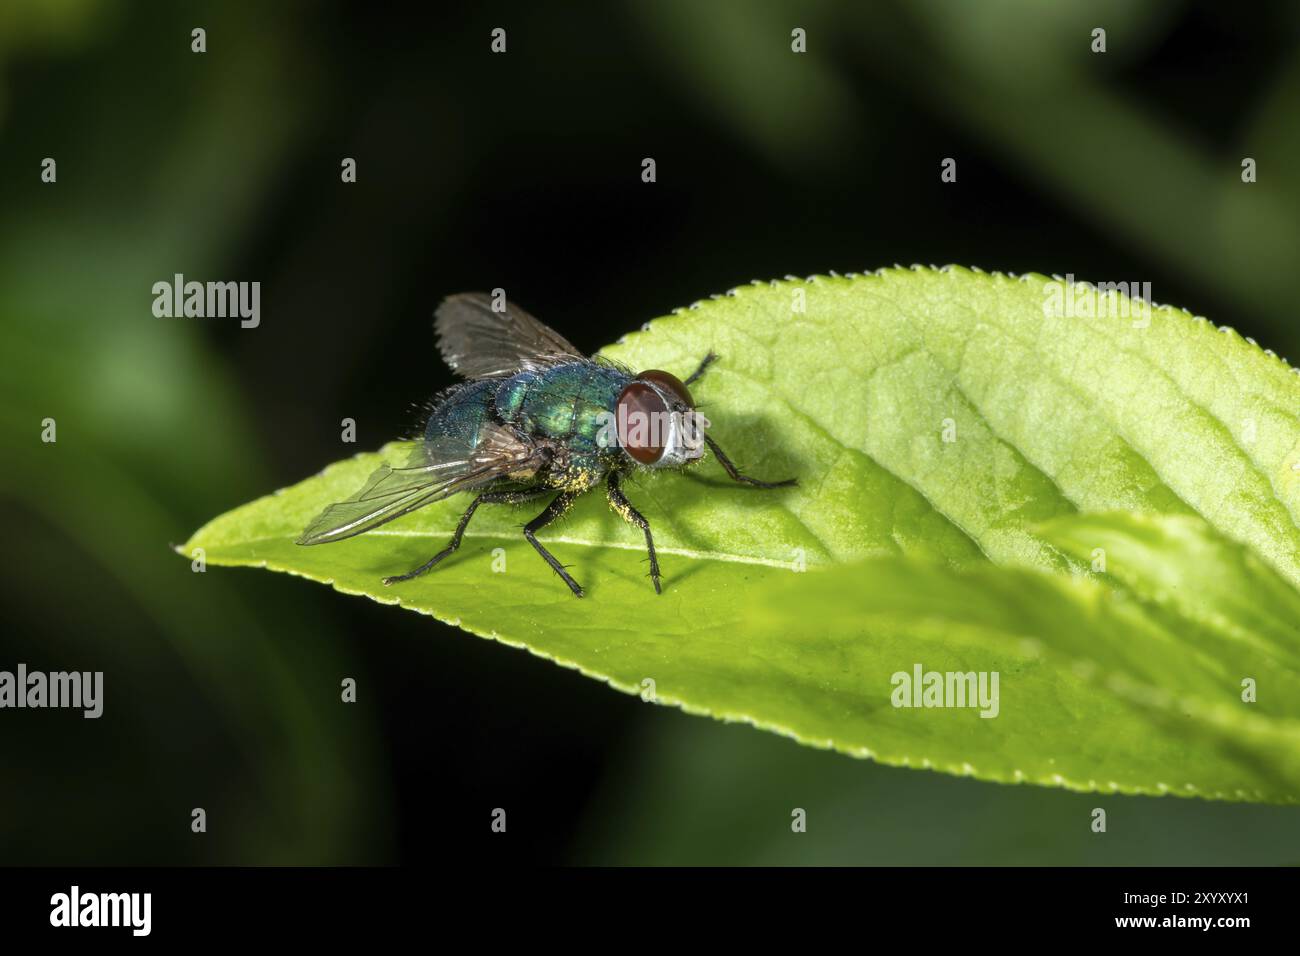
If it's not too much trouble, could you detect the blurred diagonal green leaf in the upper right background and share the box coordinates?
[852,0,1300,347]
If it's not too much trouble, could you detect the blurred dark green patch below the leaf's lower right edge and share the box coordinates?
[572,713,1300,866]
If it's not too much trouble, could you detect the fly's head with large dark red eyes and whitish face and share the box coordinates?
[602,369,709,468]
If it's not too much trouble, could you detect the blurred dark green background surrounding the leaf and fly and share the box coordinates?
[0,0,1300,865]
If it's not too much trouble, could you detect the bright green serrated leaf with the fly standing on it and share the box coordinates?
[181,269,1300,801]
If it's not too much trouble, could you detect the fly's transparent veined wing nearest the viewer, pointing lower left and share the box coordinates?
[298,425,540,545]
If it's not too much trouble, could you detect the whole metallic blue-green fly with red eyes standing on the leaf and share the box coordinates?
[298,293,796,597]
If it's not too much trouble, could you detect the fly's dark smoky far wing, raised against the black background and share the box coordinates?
[433,293,582,378]
